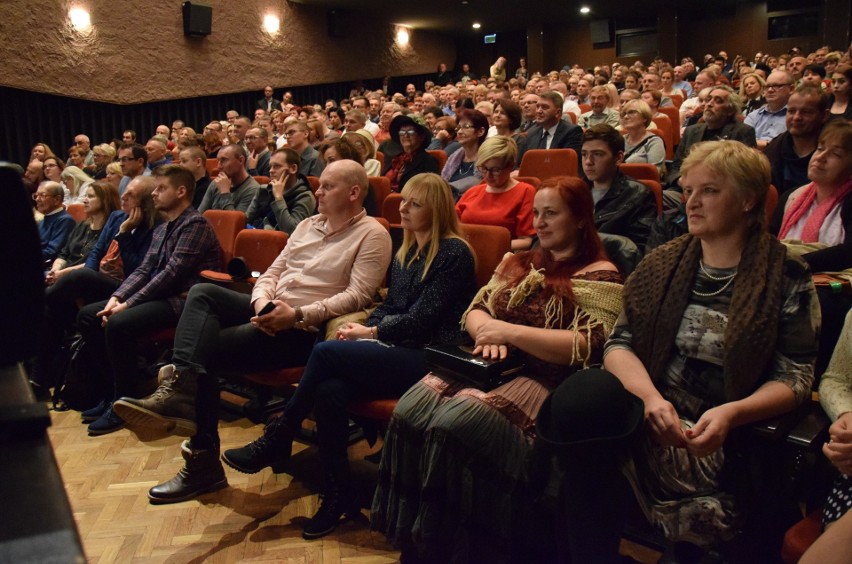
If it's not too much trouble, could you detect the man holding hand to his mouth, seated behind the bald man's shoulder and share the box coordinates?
[246,148,316,235]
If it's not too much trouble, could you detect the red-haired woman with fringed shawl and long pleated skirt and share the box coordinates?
[371,176,621,562]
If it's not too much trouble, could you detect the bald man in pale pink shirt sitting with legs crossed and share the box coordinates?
[110,160,391,503]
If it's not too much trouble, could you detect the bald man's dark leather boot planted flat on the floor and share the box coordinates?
[148,440,228,505]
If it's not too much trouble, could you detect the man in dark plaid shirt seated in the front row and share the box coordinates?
[77,165,220,435]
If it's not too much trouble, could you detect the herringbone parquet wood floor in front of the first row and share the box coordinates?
[49,411,659,564]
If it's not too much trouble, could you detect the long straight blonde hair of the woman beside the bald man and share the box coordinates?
[396,172,476,280]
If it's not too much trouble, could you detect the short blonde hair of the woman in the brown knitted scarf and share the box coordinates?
[680,140,772,228]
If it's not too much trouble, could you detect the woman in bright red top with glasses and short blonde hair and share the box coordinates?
[456,135,535,251]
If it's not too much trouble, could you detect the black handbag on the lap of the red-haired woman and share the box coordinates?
[425,345,524,392]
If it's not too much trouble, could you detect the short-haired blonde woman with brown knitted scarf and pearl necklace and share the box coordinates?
[539,141,819,562]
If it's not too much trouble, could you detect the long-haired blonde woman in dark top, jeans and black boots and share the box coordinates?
[222,174,476,539]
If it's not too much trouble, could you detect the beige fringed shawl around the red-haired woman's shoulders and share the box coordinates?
[461,266,622,367]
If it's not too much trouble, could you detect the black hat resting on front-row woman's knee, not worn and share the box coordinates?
[536,368,645,450]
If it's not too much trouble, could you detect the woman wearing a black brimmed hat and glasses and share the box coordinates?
[382,116,441,192]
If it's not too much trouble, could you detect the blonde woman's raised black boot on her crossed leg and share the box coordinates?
[222,415,296,474]
